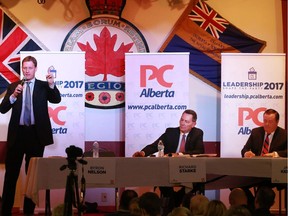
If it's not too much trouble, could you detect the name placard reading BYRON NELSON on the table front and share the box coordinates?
[84,158,116,185]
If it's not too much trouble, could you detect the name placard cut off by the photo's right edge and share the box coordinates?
[271,158,288,183]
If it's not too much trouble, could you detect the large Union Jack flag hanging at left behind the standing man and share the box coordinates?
[0,7,46,98]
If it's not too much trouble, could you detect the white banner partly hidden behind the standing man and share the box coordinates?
[21,52,85,157]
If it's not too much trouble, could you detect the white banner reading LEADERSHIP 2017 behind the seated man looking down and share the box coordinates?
[221,53,285,157]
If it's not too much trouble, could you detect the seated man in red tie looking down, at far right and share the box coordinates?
[241,109,287,157]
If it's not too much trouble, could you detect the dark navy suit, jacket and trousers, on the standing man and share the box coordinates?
[0,79,61,216]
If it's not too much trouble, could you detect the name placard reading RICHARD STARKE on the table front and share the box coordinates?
[169,157,206,183]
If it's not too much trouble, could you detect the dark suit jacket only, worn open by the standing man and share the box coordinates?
[0,79,61,146]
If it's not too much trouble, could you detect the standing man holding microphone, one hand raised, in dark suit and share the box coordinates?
[0,56,61,216]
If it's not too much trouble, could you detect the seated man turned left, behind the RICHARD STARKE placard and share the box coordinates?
[133,110,204,214]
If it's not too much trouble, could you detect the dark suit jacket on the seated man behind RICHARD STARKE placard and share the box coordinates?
[142,127,204,156]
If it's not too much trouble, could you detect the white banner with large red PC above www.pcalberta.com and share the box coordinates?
[125,53,189,156]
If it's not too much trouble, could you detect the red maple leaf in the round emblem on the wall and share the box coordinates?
[77,27,133,81]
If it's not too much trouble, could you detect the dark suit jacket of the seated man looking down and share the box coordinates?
[241,127,287,157]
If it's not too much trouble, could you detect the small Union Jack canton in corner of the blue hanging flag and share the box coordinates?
[188,1,229,38]
